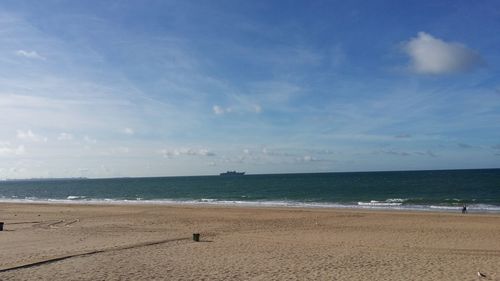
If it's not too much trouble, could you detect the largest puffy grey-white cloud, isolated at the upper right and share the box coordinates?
[404,32,483,74]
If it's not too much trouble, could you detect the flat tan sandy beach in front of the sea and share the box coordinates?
[0,204,500,280]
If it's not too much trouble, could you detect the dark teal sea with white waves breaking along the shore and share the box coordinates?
[0,169,500,213]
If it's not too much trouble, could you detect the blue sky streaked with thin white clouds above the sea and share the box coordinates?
[0,0,500,179]
